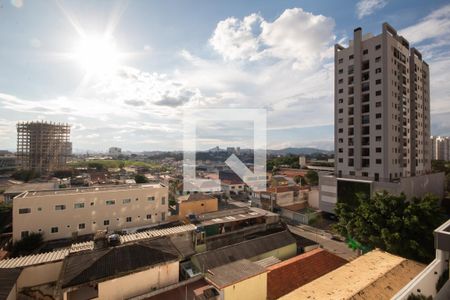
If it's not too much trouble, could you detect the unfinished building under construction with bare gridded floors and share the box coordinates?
[16,122,72,174]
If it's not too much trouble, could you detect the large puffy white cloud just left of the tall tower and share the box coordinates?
[209,8,335,69]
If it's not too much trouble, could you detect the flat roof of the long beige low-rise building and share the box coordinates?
[17,183,164,198]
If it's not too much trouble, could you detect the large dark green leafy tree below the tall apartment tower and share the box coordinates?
[335,192,445,263]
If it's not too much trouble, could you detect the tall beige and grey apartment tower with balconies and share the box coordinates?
[335,23,431,181]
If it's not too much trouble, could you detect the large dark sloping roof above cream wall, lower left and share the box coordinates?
[60,237,180,288]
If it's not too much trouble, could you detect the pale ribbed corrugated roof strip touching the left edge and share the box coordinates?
[0,249,69,268]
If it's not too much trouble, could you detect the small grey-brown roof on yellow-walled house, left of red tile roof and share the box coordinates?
[205,259,266,289]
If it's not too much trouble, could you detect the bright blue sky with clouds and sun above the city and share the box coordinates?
[0,0,450,152]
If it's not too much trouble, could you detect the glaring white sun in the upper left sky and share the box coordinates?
[74,36,119,74]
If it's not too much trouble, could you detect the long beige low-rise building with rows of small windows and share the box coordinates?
[13,184,168,240]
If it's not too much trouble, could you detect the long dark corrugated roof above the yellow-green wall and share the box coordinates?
[192,230,295,271]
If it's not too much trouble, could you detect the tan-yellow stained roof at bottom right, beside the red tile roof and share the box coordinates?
[280,250,420,300]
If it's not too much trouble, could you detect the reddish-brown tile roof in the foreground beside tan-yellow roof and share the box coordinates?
[267,248,347,300]
